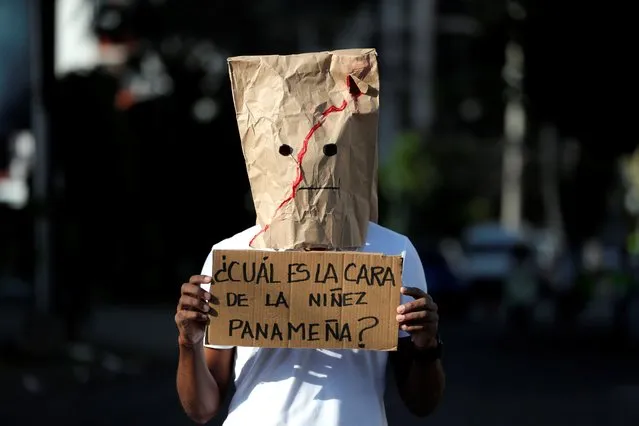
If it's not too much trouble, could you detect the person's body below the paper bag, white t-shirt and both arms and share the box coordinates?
[175,223,445,426]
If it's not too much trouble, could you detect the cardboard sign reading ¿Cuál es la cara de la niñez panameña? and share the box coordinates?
[207,250,403,351]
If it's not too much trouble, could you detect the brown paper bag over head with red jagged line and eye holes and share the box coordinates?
[228,49,379,249]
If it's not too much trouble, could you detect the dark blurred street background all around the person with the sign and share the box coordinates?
[0,0,639,426]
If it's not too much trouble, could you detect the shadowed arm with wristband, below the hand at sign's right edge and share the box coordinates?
[391,337,446,417]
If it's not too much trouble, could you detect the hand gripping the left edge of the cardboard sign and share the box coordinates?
[175,275,215,346]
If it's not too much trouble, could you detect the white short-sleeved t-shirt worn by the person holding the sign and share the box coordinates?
[202,223,426,426]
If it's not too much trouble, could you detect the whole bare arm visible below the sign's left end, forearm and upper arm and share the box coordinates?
[177,344,235,424]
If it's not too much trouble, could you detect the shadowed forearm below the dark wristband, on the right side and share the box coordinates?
[400,360,446,416]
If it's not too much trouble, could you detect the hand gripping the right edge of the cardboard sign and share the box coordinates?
[397,287,439,349]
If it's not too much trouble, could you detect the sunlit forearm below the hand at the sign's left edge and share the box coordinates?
[177,345,221,424]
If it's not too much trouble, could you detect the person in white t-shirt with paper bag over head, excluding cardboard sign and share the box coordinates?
[175,49,445,426]
